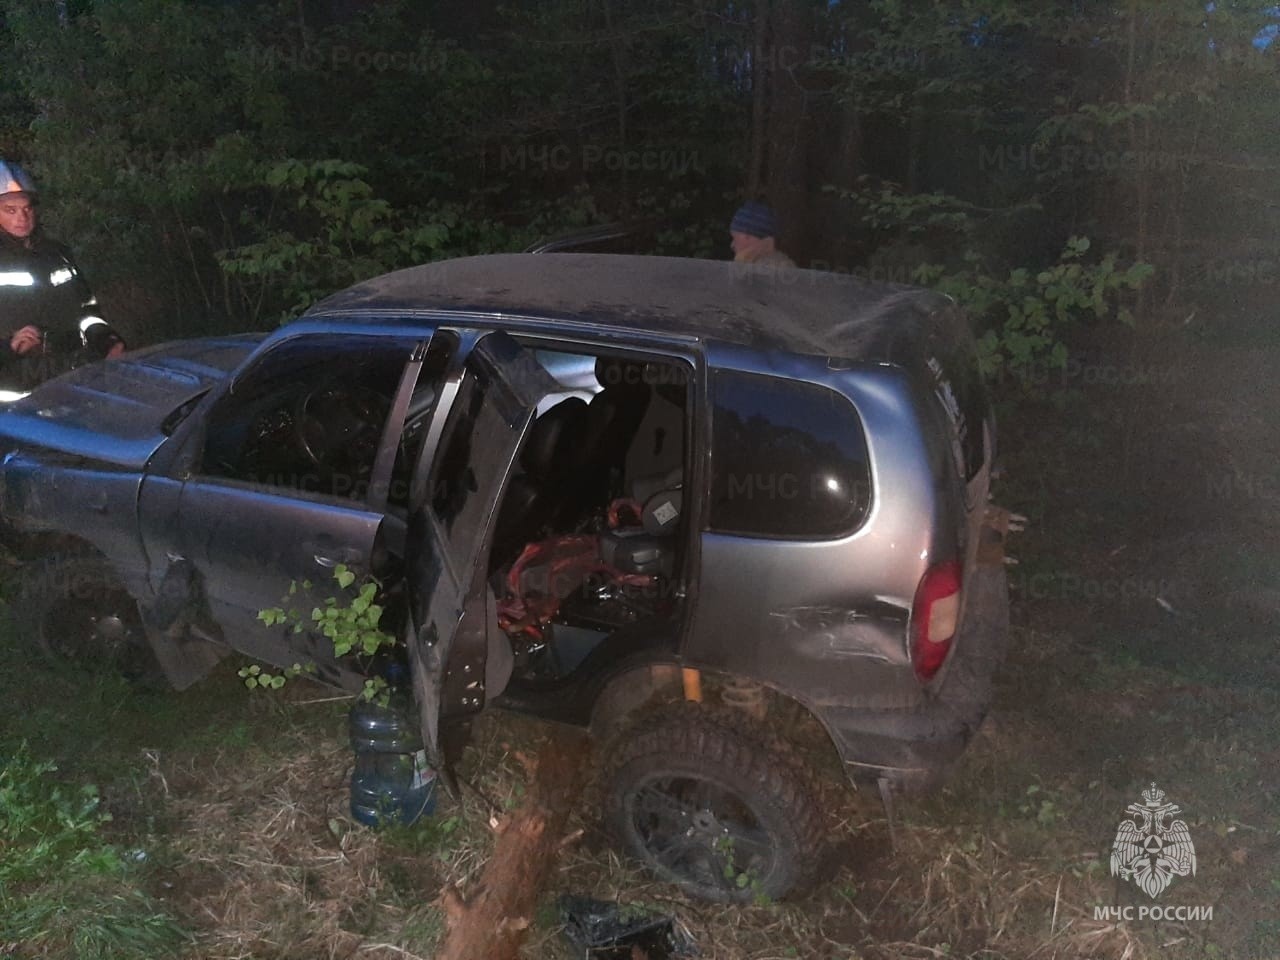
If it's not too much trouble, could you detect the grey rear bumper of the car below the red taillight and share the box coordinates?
[817,562,1009,792]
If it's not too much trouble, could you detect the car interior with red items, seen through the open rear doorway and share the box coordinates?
[489,351,690,684]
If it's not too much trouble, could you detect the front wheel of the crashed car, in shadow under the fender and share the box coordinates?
[9,554,161,682]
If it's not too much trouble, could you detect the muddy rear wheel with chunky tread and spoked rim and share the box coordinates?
[603,704,823,902]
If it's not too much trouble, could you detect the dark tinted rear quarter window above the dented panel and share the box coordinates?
[710,370,870,538]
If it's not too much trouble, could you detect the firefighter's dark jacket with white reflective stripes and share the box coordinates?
[0,230,123,389]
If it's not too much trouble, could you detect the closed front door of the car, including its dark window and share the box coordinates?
[143,334,440,689]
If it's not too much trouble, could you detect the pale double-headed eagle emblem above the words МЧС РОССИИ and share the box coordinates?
[1111,783,1196,900]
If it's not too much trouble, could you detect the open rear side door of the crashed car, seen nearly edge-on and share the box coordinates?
[406,333,558,765]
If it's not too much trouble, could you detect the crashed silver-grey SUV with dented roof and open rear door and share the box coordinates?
[0,253,1007,900]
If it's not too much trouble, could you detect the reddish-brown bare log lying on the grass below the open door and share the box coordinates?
[436,728,590,960]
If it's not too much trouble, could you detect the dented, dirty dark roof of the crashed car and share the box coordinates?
[305,253,951,362]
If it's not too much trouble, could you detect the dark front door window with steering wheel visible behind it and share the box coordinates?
[200,334,419,499]
